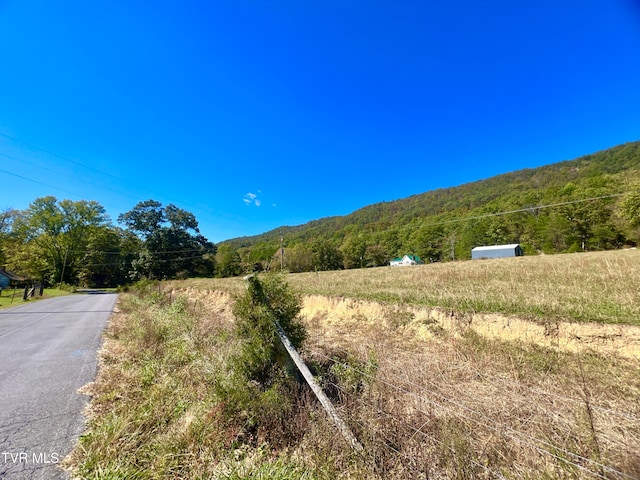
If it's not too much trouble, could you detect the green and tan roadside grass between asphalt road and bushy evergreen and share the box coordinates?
[65,284,350,480]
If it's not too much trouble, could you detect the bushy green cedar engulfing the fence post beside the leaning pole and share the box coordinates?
[214,273,306,442]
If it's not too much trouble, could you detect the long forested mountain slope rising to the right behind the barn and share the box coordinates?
[218,142,640,274]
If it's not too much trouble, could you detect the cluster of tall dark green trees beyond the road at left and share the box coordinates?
[0,196,216,287]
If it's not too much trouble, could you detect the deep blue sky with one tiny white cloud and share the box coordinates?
[0,0,640,242]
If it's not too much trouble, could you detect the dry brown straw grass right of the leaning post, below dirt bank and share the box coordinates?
[298,296,640,478]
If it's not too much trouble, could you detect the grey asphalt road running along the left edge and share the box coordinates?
[0,294,117,480]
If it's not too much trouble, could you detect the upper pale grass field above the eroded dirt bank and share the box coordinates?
[174,250,640,325]
